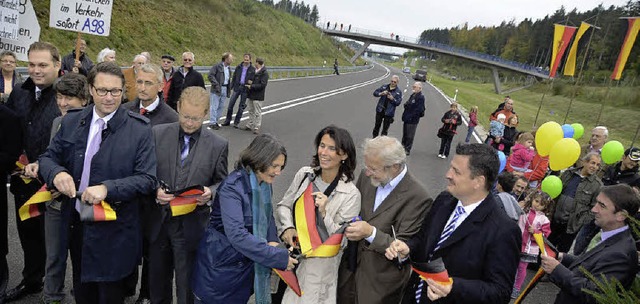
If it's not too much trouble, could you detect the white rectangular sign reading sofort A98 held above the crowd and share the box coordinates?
[49,0,113,36]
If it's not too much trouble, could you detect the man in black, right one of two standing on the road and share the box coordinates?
[402,81,425,155]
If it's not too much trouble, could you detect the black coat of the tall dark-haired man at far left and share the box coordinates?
[7,78,61,162]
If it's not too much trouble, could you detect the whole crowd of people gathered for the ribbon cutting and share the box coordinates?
[0,42,640,304]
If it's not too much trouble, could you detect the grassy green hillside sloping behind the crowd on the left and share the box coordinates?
[32,0,350,66]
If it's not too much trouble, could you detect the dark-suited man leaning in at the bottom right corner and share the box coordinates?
[541,184,640,303]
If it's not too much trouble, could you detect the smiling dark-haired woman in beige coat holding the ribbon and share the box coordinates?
[275,125,360,304]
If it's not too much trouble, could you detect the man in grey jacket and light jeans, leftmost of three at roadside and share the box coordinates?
[209,53,233,130]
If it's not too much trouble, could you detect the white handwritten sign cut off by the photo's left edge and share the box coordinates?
[0,0,40,61]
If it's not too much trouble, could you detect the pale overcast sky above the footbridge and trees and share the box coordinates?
[304,0,627,38]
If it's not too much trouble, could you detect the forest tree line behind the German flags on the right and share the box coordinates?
[420,0,640,76]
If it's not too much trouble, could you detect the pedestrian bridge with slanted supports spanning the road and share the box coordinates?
[320,27,550,94]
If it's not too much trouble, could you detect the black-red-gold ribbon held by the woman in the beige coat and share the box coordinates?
[294,183,348,258]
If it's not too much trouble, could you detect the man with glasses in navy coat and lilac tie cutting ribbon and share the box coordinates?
[40,62,156,304]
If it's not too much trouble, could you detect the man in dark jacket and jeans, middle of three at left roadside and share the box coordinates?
[222,53,256,128]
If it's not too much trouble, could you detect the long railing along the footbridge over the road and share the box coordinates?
[317,22,549,75]
